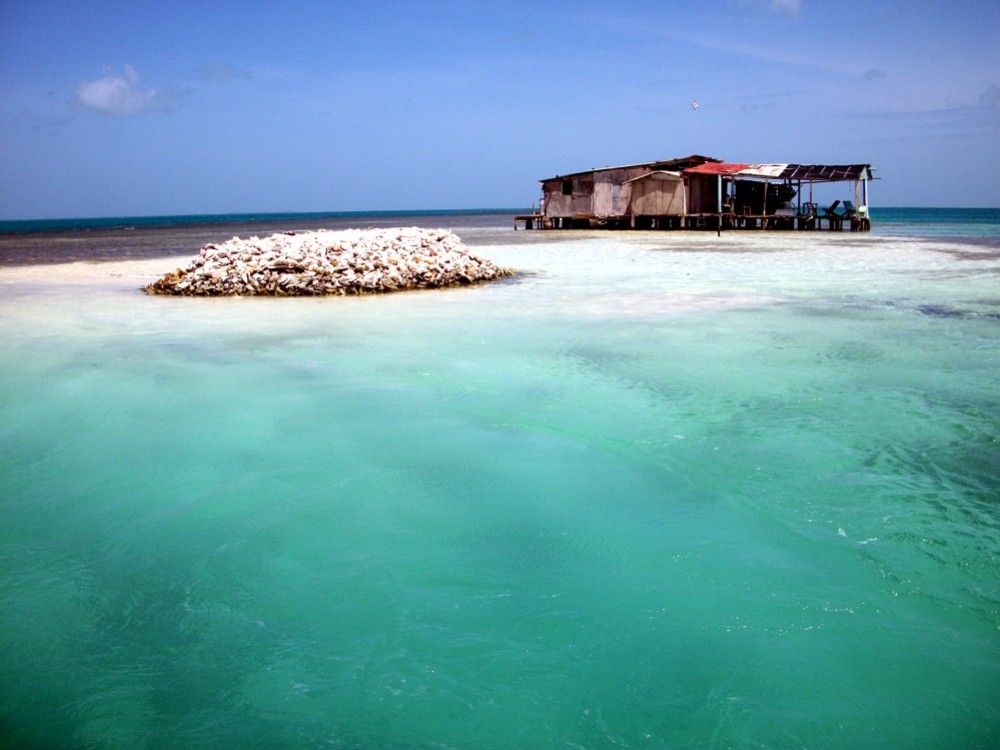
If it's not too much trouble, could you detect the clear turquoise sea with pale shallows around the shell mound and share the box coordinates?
[0,209,1000,750]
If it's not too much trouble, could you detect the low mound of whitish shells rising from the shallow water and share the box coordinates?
[143,227,514,296]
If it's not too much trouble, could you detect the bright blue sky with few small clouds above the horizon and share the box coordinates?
[0,0,1000,219]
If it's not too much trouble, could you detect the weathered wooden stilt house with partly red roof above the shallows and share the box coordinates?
[514,154,876,231]
